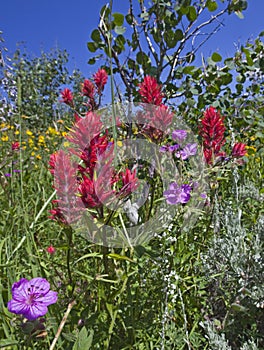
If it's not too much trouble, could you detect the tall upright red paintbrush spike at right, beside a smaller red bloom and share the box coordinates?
[199,107,225,164]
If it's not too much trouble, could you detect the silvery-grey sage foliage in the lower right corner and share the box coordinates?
[202,202,264,350]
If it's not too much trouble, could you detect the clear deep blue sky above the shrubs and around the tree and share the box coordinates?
[0,0,264,76]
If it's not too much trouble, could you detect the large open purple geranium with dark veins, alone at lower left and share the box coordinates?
[7,277,58,320]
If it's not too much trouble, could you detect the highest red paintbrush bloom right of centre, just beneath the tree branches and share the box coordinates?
[139,75,163,106]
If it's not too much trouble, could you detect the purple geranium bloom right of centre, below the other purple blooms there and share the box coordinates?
[163,182,192,204]
